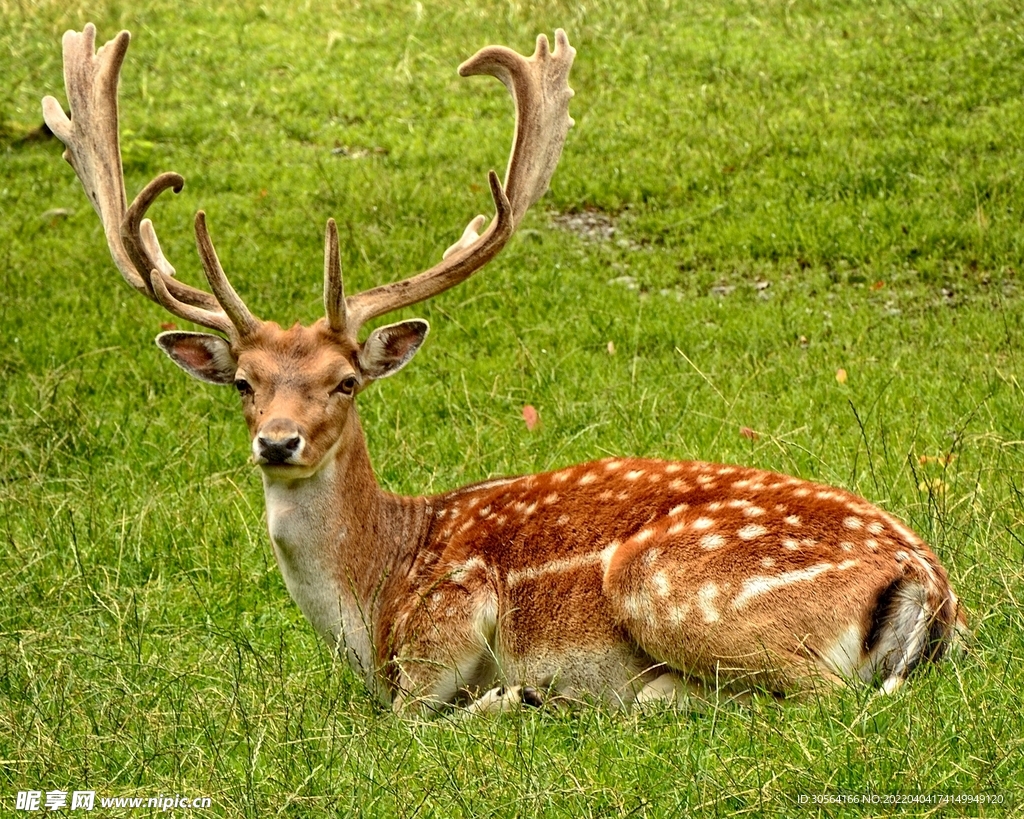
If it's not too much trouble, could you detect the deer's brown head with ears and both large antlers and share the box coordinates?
[43,24,575,478]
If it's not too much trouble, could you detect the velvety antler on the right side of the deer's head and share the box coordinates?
[335,29,575,338]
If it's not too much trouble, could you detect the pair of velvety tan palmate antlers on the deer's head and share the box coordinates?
[43,24,575,343]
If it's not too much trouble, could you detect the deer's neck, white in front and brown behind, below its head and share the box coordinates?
[263,412,429,688]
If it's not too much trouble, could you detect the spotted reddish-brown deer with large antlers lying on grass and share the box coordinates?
[43,24,967,715]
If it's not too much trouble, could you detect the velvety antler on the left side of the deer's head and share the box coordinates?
[43,23,259,338]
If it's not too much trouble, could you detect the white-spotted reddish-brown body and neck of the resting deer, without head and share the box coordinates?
[256,403,958,708]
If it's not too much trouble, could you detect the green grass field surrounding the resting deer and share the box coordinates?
[0,0,1024,817]
